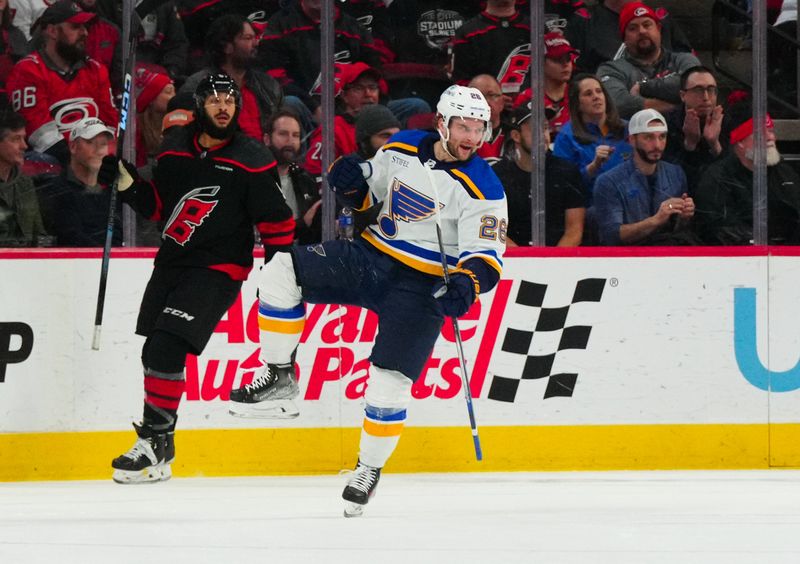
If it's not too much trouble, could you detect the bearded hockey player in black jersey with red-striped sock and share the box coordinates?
[100,74,294,483]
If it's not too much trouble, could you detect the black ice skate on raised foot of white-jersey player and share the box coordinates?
[228,363,300,419]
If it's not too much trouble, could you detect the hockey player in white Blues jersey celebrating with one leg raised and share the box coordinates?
[231,86,508,517]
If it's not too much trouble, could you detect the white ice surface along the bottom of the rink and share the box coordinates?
[0,470,800,564]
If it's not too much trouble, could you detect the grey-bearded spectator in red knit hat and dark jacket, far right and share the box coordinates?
[695,101,800,245]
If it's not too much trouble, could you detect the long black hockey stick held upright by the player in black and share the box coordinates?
[92,2,141,351]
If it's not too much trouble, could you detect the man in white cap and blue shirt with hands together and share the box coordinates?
[594,109,694,245]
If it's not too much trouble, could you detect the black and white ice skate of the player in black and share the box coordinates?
[111,423,170,484]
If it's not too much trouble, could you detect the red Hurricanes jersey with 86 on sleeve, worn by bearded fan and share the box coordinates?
[6,51,119,152]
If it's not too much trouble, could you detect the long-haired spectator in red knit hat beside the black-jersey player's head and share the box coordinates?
[133,64,175,167]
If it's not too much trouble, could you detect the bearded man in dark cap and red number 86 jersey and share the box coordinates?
[7,0,119,165]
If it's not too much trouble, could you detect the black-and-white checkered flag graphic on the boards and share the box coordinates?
[488,278,606,402]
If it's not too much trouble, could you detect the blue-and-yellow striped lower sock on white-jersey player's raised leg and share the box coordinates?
[258,301,306,364]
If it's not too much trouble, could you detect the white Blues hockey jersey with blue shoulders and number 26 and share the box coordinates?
[360,130,508,276]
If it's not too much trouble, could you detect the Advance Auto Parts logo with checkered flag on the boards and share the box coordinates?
[186,278,606,402]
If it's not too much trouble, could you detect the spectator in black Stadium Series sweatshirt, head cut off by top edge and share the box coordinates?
[383,0,481,107]
